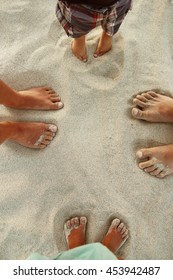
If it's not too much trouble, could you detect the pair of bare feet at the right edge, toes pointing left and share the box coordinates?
[132,91,173,178]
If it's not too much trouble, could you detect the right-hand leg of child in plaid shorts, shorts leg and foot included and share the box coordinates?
[94,0,132,57]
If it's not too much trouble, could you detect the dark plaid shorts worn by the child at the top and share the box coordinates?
[56,0,132,38]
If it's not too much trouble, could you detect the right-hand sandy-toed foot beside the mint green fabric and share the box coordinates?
[101,219,128,253]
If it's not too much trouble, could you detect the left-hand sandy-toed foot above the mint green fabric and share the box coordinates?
[64,217,87,249]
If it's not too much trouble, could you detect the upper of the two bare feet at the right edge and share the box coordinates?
[132,91,173,123]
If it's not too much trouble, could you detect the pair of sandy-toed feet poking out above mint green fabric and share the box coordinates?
[64,217,128,253]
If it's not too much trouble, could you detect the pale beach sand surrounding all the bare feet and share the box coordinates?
[0,0,173,259]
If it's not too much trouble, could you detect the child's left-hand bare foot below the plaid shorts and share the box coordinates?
[72,36,88,62]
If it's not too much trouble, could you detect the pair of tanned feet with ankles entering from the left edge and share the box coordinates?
[0,80,64,149]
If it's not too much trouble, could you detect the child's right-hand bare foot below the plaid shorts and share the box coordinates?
[94,31,112,58]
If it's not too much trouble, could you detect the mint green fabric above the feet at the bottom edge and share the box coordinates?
[28,243,117,260]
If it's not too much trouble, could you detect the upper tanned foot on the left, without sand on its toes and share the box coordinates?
[4,87,64,110]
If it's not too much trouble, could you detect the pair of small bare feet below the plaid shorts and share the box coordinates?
[72,31,112,62]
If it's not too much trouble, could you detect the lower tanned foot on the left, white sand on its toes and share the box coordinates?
[4,122,57,149]
